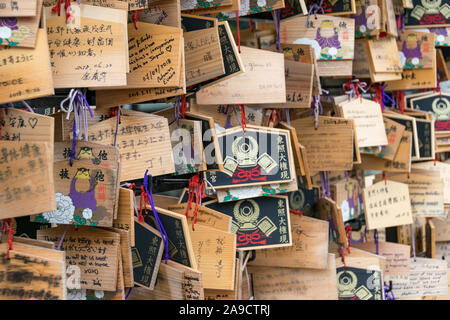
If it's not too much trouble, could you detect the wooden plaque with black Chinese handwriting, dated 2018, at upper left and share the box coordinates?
[44,4,128,88]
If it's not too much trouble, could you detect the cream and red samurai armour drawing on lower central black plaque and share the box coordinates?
[231,199,277,246]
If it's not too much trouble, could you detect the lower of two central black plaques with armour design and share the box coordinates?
[203,196,292,251]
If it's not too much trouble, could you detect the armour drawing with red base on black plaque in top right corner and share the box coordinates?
[411,0,450,25]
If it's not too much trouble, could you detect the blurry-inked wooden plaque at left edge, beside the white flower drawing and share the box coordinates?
[0,141,56,219]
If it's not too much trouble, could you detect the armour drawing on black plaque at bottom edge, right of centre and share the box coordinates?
[337,269,373,300]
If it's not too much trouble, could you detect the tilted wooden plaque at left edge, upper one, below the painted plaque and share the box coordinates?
[0,29,55,103]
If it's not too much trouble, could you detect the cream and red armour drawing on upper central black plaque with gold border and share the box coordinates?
[223,135,278,182]
